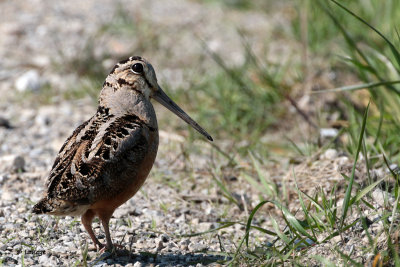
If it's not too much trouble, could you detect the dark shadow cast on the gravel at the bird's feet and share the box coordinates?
[88,250,231,266]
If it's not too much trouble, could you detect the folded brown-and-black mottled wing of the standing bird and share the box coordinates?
[47,115,150,204]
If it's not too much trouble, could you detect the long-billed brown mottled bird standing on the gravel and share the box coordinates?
[33,56,213,250]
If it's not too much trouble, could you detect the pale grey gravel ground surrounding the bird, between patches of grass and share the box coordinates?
[0,0,392,266]
